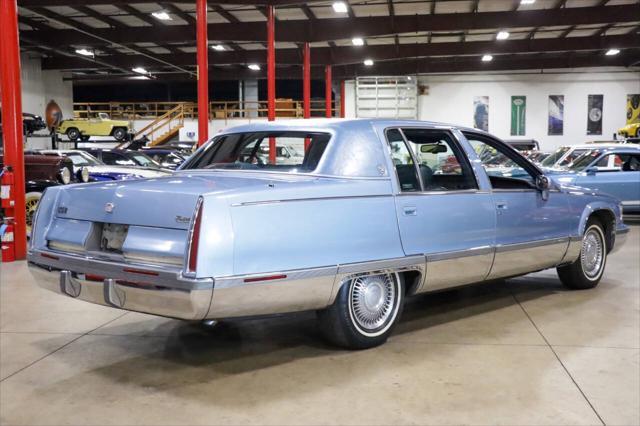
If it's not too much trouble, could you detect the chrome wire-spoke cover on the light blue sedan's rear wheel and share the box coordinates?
[349,274,400,336]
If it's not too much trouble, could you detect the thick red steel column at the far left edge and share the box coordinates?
[0,0,27,260]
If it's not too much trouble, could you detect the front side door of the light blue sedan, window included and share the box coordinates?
[464,132,571,279]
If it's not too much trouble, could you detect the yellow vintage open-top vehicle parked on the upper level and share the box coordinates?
[56,112,133,142]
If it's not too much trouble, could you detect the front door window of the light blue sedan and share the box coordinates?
[464,133,535,189]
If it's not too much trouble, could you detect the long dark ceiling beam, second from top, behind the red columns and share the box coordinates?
[42,34,640,70]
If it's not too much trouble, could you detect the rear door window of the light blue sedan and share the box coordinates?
[402,129,478,191]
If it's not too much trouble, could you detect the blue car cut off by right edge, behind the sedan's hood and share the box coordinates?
[550,145,640,214]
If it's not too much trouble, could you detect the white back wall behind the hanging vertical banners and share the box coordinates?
[345,69,640,150]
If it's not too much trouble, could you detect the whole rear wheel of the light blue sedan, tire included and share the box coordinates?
[318,273,404,349]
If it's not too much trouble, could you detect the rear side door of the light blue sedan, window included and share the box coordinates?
[386,128,496,291]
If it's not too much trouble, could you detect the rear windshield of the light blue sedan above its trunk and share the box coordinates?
[181,131,331,173]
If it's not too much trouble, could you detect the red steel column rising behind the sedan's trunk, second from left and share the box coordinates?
[196,0,209,146]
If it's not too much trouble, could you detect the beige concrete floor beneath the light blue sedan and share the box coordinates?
[0,225,640,425]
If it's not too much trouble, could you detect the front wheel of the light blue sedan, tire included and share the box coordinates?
[557,219,607,290]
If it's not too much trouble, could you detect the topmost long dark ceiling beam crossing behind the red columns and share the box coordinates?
[25,3,640,44]
